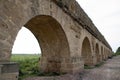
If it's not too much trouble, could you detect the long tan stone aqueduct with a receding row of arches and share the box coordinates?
[0,0,112,79]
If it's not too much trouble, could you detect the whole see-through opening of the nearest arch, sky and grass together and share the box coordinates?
[10,27,41,80]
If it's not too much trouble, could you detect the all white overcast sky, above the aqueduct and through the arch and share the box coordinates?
[12,0,120,53]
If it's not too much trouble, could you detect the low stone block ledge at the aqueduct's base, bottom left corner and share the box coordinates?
[0,62,19,80]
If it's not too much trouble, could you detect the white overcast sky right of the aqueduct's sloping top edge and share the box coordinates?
[77,0,120,51]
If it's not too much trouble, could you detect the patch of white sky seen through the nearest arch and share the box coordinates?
[12,26,41,54]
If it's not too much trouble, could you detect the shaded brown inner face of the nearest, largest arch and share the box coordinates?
[24,15,70,73]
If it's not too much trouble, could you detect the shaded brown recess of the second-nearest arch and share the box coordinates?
[81,37,93,65]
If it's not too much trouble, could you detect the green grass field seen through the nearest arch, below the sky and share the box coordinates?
[11,54,40,80]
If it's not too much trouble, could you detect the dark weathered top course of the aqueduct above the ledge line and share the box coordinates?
[53,0,112,50]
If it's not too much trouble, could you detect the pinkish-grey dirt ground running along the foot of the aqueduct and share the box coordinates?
[25,56,120,80]
